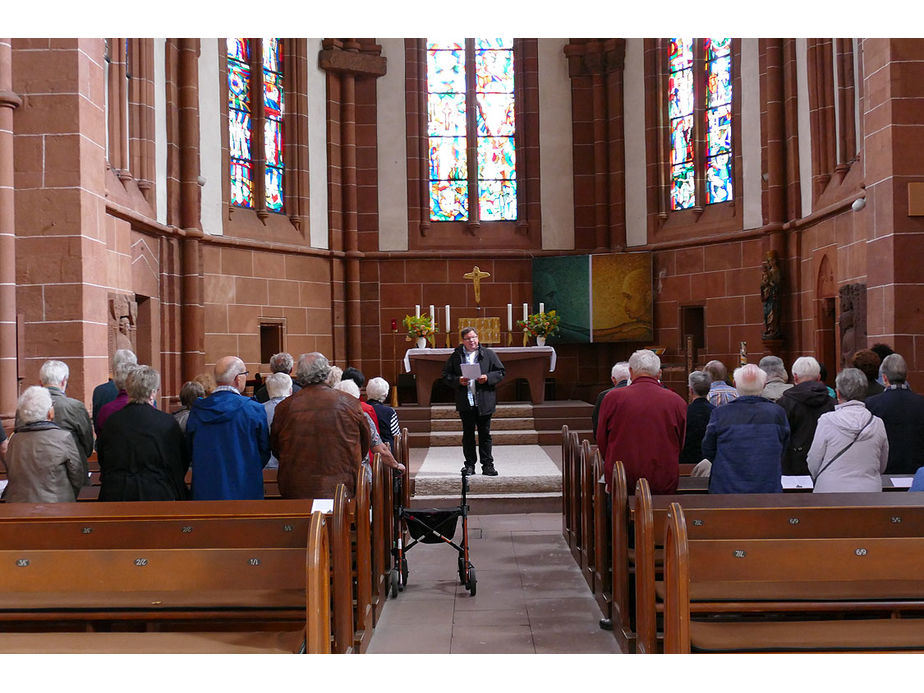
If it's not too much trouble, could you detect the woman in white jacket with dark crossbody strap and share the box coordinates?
[807,368,889,493]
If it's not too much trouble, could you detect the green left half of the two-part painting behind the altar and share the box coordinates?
[532,255,590,344]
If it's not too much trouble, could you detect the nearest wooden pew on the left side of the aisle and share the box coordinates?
[0,500,331,653]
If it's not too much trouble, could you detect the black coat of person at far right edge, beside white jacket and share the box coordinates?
[866,389,924,474]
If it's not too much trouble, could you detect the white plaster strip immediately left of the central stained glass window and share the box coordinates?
[376,38,408,250]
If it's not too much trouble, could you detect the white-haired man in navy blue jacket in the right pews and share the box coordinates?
[703,363,792,493]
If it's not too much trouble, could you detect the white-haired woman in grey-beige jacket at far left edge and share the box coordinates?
[3,385,87,503]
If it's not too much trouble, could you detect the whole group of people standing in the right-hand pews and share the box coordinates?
[594,344,924,494]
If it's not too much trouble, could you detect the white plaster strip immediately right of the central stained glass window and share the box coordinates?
[538,38,574,250]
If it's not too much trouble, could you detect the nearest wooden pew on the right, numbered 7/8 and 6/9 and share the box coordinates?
[664,502,924,653]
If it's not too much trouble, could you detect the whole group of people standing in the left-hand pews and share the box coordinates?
[0,349,404,503]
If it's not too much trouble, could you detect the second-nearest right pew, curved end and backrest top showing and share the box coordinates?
[632,479,924,654]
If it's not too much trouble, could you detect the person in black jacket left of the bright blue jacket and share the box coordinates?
[98,366,189,501]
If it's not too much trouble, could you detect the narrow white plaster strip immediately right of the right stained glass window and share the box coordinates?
[732,39,763,229]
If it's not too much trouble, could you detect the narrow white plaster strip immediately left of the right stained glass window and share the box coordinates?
[622,38,648,246]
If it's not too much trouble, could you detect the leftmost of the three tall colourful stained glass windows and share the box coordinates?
[227,38,285,212]
